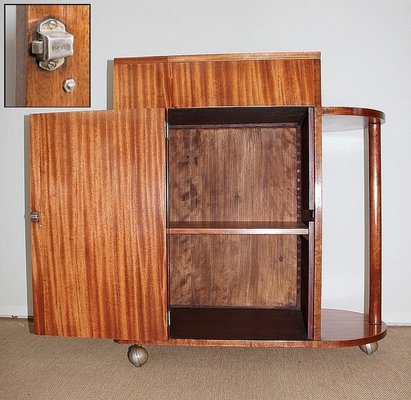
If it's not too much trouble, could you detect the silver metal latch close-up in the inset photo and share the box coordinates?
[31,18,74,71]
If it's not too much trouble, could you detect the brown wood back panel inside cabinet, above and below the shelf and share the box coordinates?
[168,126,298,308]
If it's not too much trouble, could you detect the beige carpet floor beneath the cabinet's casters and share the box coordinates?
[0,319,411,400]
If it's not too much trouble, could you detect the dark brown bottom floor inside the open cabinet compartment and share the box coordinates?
[170,307,307,340]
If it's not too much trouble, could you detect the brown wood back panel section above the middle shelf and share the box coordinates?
[168,126,298,222]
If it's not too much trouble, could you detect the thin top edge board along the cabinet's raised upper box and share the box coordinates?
[114,52,321,64]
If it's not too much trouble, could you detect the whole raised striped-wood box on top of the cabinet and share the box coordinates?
[113,53,321,108]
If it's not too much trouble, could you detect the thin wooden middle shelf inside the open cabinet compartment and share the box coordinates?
[168,221,308,235]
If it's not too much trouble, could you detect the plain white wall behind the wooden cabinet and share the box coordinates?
[0,0,411,324]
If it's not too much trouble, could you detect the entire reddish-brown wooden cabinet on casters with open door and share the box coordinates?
[30,53,386,365]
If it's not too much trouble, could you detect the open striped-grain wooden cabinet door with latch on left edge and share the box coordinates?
[30,109,167,343]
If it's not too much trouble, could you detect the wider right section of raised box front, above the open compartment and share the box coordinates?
[169,59,320,107]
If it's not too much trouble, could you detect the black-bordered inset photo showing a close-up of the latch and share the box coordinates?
[4,4,91,107]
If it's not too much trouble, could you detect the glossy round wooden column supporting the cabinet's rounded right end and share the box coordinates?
[368,122,382,324]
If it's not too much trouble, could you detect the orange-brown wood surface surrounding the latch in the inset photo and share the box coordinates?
[16,4,90,107]
